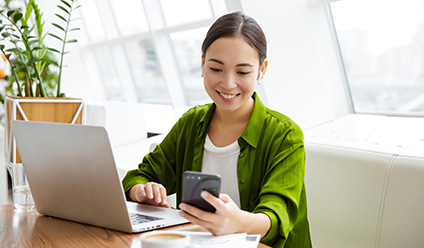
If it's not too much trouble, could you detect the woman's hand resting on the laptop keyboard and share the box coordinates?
[130,182,171,208]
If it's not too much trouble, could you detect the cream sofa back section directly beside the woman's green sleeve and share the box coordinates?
[305,143,392,248]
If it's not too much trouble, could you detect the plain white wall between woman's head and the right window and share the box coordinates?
[241,0,352,128]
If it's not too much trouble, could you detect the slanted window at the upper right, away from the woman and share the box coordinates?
[330,0,424,115]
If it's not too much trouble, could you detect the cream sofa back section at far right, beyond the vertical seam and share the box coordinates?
[377,156,424,248]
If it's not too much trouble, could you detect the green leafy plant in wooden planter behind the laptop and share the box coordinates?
[0,0,84,164]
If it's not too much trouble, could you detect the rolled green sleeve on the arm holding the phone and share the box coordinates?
[253,129,305,244]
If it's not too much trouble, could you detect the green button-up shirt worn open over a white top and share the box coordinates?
[122,93,311,248]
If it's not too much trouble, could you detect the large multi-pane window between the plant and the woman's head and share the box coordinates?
[79,0,235,105]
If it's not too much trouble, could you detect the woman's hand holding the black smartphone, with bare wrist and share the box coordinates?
[179,191,271,236]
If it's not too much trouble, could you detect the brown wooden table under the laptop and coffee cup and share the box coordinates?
[0,205,268,248]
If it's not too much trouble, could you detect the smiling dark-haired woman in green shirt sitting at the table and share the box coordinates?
[123,12,311,247]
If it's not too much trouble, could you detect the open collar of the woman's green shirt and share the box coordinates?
[197,92,266,148]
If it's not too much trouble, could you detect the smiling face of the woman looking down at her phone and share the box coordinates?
[202,37,263,115]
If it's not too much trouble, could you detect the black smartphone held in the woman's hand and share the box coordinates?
[182,171,221,212]
